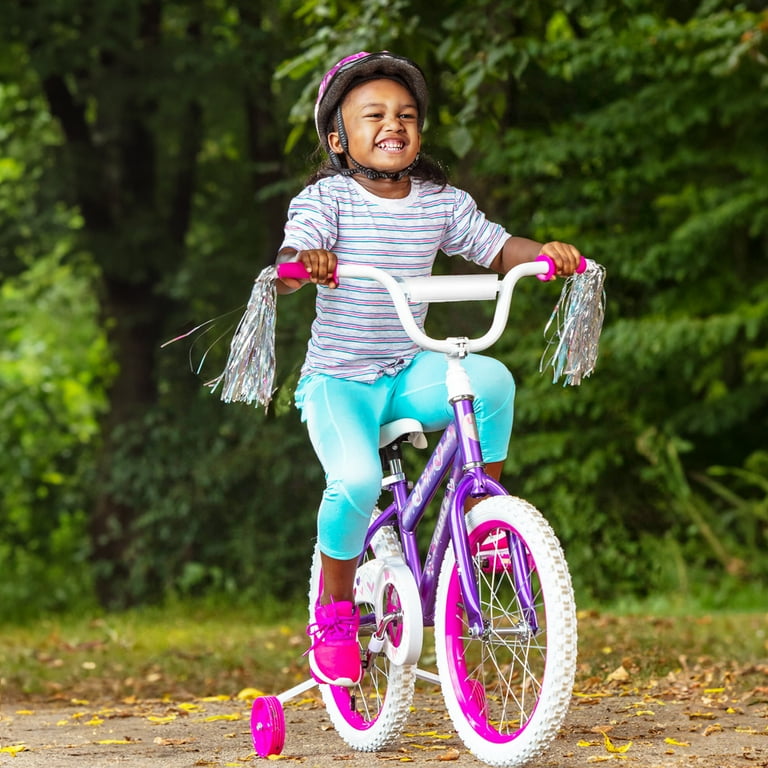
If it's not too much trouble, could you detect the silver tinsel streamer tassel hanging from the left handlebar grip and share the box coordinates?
[207,266,277,408]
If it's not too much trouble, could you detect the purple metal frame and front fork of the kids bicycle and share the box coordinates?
[366,397,537,637]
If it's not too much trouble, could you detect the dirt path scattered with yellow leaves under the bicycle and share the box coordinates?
[0,684,768,768]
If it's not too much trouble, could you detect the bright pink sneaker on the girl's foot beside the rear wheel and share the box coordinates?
[307,600,363,686]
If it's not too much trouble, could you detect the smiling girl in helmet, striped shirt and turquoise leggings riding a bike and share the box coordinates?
[277,51,582,686]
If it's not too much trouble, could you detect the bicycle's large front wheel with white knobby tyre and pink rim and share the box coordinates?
[435,496,577,766]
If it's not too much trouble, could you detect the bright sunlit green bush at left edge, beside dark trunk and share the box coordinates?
[0,249,109,618]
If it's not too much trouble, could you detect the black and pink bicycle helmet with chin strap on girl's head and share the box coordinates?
[315,51,429,179]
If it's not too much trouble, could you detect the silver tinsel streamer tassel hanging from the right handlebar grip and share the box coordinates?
[539,259,605,386]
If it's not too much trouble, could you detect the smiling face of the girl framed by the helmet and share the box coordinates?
[328,79,421,178]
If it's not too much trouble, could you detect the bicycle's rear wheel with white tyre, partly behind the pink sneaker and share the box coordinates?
[309,548,421,752]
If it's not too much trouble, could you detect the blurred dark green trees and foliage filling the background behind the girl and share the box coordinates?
[0,0,768,615]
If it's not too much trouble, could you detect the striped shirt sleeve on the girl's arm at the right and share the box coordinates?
[440,189,510,267]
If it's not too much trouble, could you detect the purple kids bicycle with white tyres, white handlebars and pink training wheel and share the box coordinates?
[251,257,586,766]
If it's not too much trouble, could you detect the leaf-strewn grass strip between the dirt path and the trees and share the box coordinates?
[0,603,768,701]
